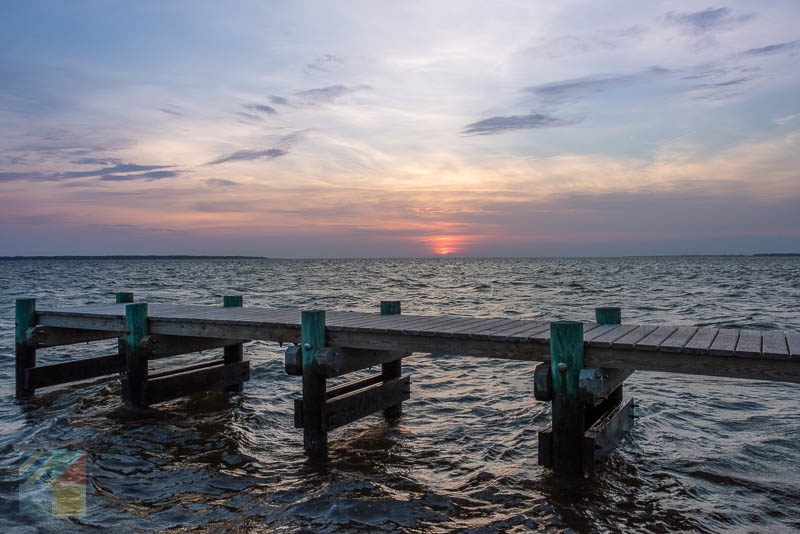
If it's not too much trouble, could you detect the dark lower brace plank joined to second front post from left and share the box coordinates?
[146,361,250,404]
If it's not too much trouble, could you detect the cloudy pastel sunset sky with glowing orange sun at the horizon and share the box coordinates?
[0,0,800,257]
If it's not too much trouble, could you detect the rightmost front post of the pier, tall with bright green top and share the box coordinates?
[550,321,584,477]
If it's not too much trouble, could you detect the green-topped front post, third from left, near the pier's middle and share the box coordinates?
[300,310,328,455]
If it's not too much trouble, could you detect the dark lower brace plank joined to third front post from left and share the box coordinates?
[324,376,411,431]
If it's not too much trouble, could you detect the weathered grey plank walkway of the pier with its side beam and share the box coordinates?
[36,303,800,383]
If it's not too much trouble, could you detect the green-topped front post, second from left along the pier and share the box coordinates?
[122,302,149,409]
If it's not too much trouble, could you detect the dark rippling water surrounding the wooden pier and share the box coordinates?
[0,257,800,533]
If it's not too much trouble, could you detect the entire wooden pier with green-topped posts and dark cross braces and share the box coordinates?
[16,293,800,475]
